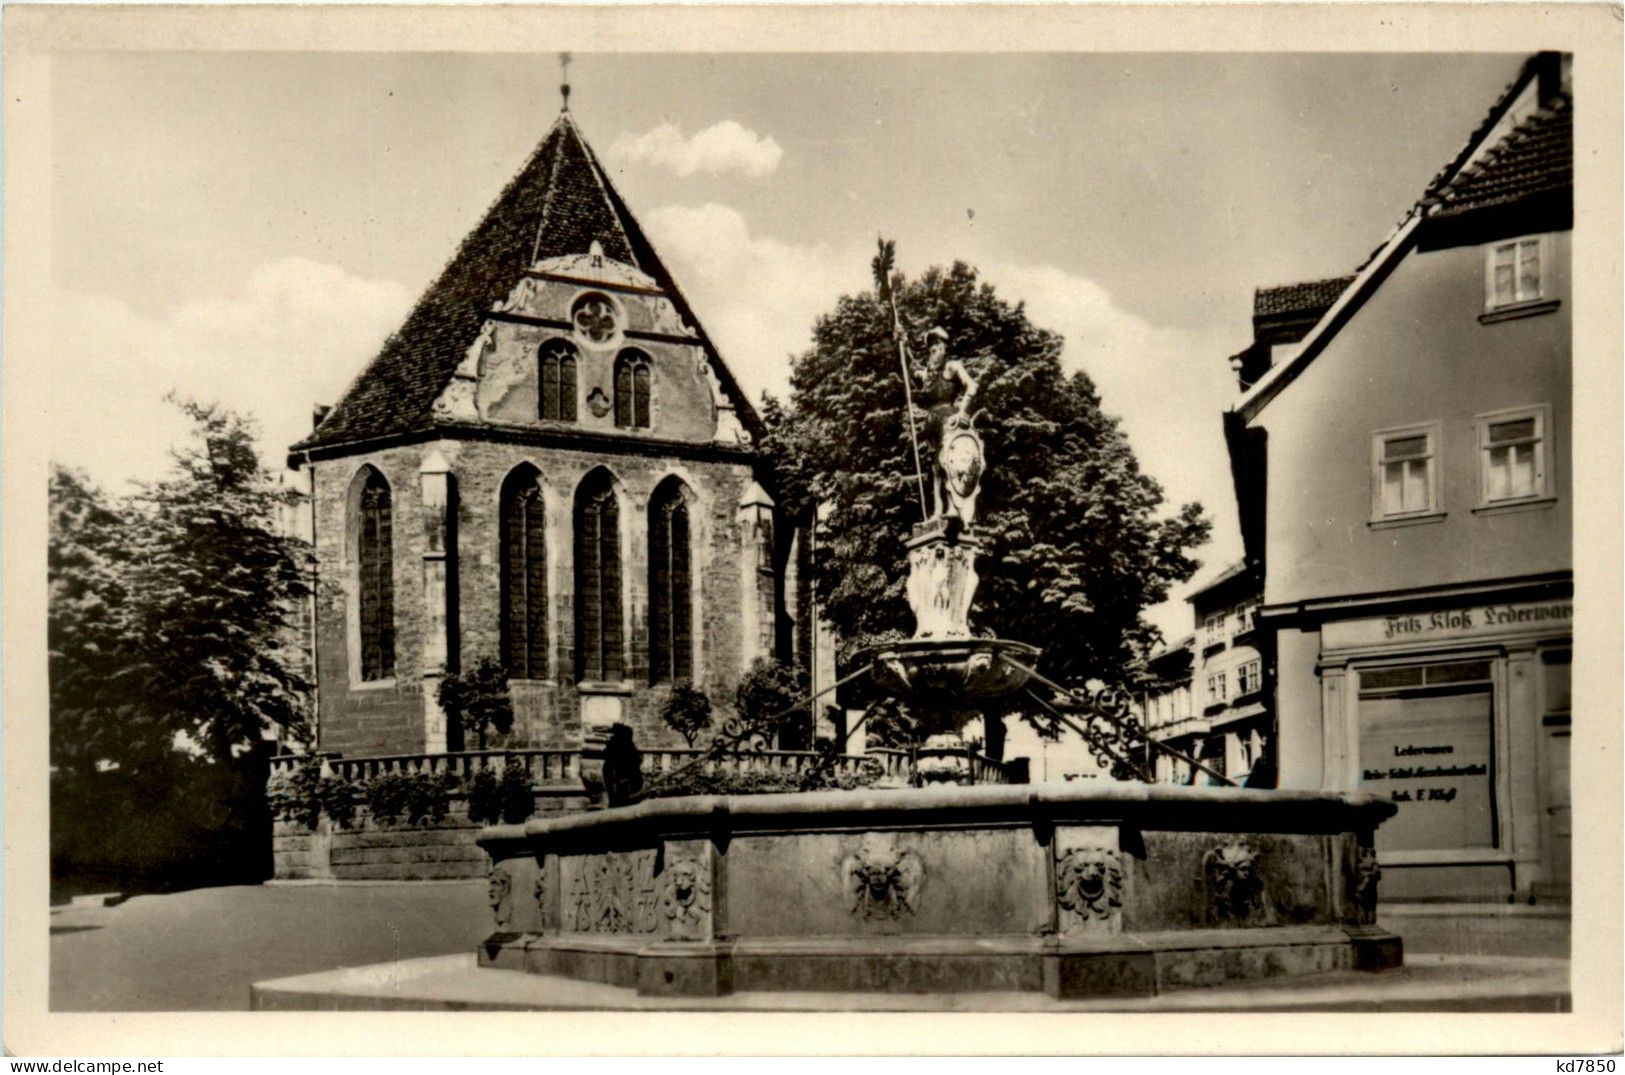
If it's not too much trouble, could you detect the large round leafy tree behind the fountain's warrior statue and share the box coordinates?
[764,263,1209,695]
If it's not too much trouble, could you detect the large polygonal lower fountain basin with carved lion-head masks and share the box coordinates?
[478,783,1401,997]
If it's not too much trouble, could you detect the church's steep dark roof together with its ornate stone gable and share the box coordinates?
[293,112,761,453]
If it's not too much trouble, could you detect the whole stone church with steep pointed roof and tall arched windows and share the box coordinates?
[289,99,791,757]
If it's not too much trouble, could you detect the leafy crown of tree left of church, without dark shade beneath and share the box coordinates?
[49,401,310,768]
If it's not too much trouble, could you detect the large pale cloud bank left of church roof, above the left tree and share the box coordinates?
[41,258,411,489]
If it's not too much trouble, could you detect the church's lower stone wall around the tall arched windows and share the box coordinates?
[314,440,774,755]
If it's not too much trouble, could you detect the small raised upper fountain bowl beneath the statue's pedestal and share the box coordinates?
[855,638,1038,710]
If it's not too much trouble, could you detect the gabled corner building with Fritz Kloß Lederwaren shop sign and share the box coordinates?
[1225,54,1573,900]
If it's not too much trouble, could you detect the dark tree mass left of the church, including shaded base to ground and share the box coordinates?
[47,401,309,880]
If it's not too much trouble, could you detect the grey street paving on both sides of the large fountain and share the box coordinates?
[50,880,1568,1012]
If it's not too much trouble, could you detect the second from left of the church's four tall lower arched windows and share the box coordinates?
[501,466,548,679]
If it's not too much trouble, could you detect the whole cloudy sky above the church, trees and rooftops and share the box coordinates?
[39,52,1523,640]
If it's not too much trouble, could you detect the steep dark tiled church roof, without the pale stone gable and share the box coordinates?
[291,112,764,451]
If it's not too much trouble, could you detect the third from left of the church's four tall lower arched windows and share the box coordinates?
[575,469,624,680]
